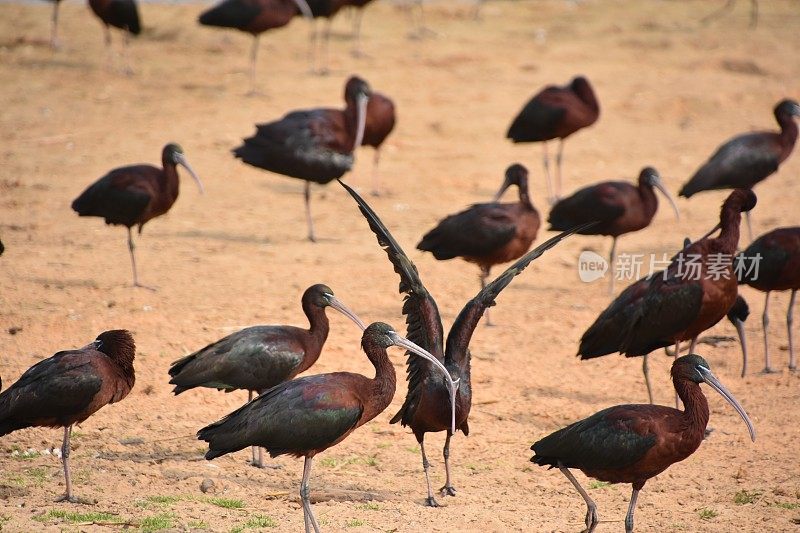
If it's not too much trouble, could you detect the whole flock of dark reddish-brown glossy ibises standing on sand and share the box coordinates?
[0,0,800,532]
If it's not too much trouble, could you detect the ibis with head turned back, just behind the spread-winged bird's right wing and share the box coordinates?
[417,163,539,324]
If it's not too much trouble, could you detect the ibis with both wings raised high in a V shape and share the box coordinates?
[340,182,583,507]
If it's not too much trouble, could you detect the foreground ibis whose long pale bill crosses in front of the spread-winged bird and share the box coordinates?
[197,322,457,533]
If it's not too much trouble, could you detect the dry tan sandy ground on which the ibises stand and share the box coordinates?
[0,0,800,532]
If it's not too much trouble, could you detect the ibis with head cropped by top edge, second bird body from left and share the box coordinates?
[198,0,311,94]
